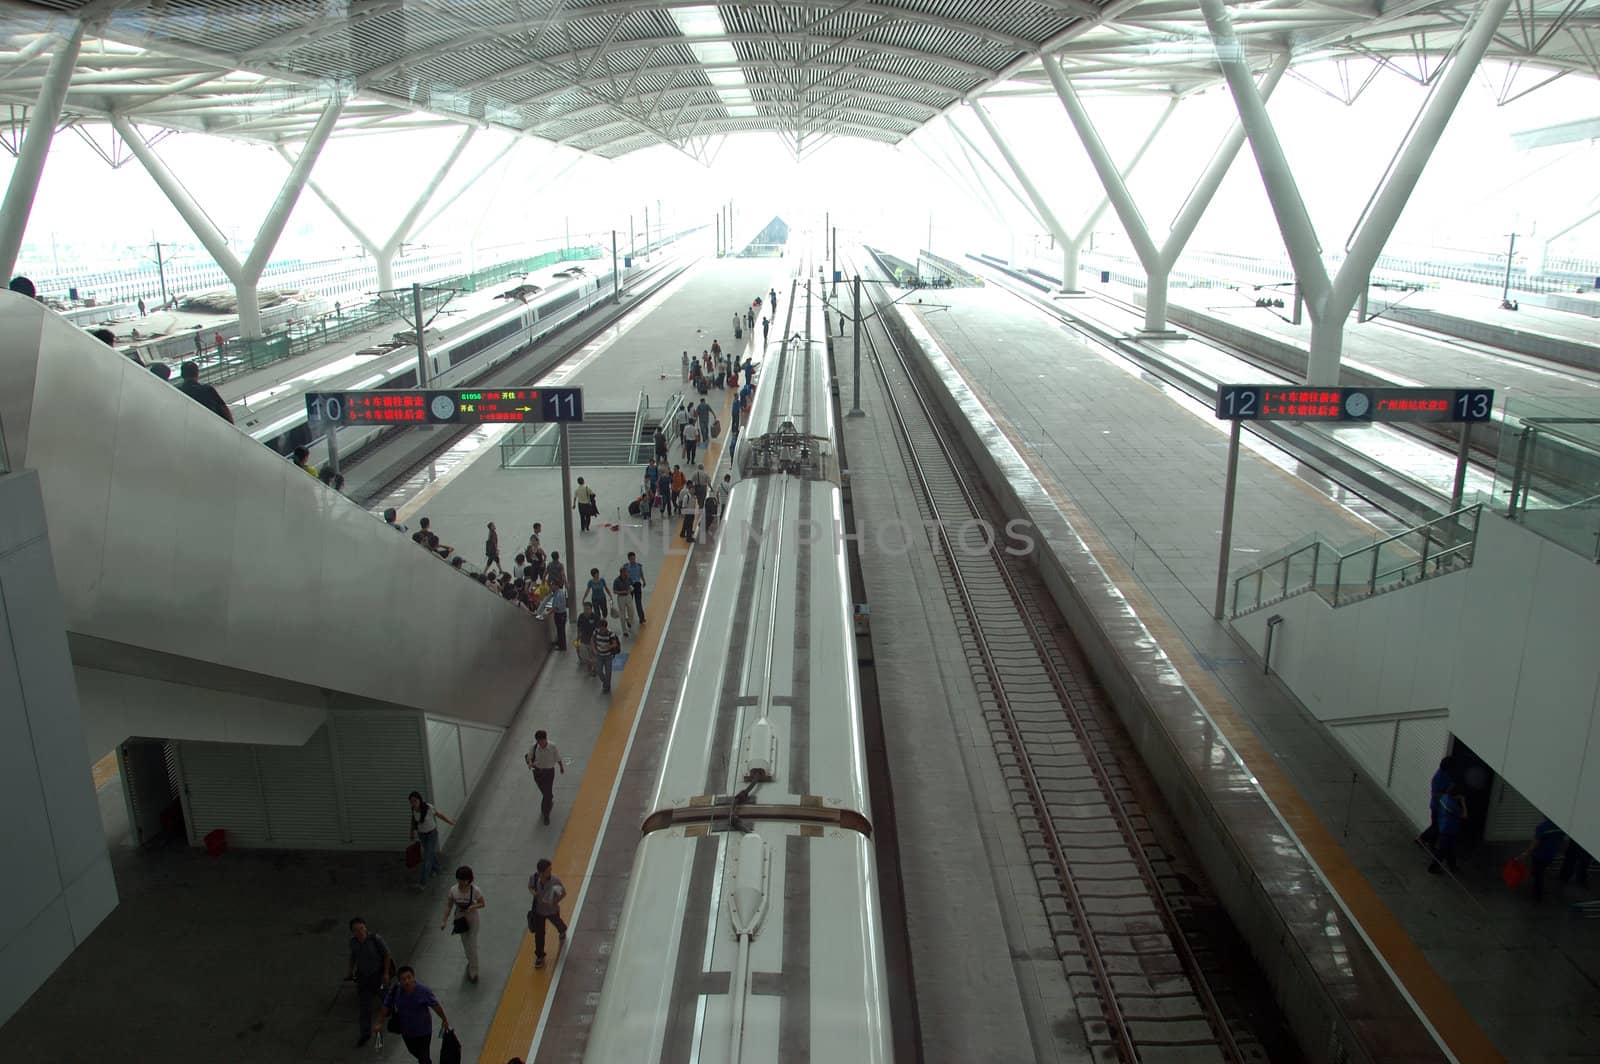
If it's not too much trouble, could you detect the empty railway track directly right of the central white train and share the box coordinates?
[862,257,1285,1064]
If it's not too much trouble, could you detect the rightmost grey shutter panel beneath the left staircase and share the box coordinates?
[328,710,425,850]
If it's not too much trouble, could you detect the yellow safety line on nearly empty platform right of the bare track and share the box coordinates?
[934,342,1506,1064]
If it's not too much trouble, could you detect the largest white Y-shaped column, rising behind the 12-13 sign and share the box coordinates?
[1200,0,1510,386]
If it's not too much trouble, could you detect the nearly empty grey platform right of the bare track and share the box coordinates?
[889,278,1600,1061]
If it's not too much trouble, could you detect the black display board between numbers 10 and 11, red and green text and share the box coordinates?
[306,387,584,426]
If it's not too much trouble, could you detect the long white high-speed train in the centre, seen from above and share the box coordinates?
[584,275,893,1064]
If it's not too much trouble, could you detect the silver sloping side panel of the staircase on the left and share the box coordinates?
[0,294,541,734]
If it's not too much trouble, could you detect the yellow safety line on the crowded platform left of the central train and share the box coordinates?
[478,384,734,1064]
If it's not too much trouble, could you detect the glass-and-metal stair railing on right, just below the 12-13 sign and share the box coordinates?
[1232,502,1483,618]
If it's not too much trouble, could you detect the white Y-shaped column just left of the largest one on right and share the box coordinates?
[1042,54,1290,333]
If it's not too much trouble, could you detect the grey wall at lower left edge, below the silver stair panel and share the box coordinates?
[0,472,117,1021]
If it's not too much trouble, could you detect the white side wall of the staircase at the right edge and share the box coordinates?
[1234,515,1600,848]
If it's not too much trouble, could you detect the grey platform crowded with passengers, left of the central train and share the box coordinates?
[0,252,779,1064]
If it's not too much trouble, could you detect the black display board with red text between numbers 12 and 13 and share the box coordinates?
[1216,384,1494,422]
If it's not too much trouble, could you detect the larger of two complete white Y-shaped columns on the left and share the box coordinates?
[110,96,344,339]
